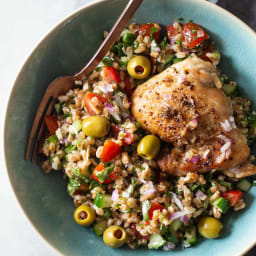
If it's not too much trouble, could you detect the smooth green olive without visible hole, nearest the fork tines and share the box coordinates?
[82,116,110,138]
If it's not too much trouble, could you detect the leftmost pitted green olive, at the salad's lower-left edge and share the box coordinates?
[74,205,96,226]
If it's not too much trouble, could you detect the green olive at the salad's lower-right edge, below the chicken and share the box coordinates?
[198,217,223,238]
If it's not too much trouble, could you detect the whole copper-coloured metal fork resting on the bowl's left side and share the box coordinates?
[25,0,143,162]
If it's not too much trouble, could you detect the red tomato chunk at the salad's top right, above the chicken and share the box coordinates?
[183,22,209,49]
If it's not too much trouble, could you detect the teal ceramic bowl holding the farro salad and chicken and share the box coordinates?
[5,0,256,256]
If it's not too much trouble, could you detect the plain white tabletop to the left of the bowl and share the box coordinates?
[0,0,92,256]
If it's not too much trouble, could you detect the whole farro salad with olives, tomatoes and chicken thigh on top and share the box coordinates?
[41,20,256,251]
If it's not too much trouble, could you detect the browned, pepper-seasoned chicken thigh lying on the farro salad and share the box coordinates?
[132,57,256,178]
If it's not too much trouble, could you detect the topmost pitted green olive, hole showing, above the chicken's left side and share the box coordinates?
[127,56,151,79]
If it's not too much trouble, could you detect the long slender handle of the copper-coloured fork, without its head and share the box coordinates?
[74,0,143,80]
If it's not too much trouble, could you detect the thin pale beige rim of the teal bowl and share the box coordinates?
[2,0,256,256]
